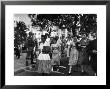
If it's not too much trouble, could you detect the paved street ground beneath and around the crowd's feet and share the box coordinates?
[14,53,88,76]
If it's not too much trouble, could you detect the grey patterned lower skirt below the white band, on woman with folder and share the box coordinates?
[37,60,51,73]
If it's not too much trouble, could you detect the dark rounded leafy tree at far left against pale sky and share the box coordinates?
[14,21,27,47]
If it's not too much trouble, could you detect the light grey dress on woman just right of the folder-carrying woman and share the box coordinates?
[51,44,61,65]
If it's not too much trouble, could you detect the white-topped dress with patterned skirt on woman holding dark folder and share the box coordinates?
[38,42,51,73]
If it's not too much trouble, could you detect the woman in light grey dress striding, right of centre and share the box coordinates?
[68,40,79,74]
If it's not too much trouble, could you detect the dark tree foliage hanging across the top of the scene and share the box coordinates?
[28,14,97,35]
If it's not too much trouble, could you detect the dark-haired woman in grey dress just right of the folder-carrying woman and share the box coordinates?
[51,38,61,71]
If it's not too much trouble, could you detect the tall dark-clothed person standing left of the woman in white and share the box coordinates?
[26,32,35,66]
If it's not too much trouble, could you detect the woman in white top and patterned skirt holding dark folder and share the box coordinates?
[38,35,51,75]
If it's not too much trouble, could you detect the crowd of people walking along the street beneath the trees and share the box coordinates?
[15,32,97,76]
